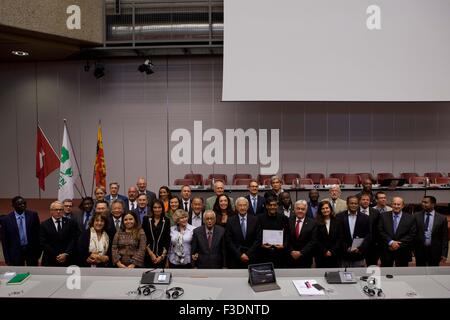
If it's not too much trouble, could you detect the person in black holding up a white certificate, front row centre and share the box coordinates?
[258,197,289,268]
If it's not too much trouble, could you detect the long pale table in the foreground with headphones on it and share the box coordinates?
[0,267,450,303]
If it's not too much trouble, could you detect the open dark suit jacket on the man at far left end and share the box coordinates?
[2,210,41,266]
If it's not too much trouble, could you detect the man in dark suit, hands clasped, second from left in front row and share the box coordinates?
[40,201,79,267]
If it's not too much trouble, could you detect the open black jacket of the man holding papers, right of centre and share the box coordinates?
[336,211,370,261]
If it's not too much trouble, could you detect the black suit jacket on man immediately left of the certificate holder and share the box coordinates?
[225,214,261,268]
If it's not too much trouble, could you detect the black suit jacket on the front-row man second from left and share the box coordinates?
[40,217,79,267]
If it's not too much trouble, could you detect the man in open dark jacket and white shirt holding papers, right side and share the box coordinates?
[336,196,370,268]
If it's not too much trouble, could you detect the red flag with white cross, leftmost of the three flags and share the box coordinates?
[36,126,59,190]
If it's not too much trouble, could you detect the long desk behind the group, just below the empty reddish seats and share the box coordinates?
[169,184,450,204]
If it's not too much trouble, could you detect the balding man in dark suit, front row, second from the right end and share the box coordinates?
[379,197,417,267]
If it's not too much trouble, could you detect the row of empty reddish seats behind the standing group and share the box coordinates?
[174,172,450,185]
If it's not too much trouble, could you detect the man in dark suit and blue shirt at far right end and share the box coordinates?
[414,196,448,266]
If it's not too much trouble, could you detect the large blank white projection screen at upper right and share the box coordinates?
[222,0,450,101]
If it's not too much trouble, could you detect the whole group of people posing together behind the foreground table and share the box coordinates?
[0,176,448,268]
